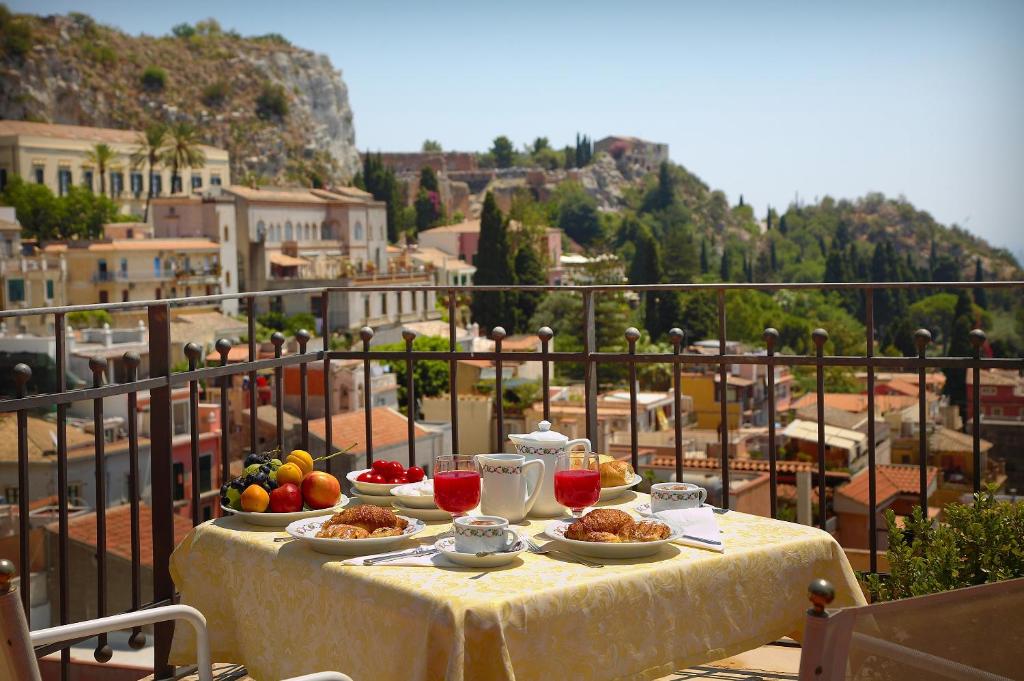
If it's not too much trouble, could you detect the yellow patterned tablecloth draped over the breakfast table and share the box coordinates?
[171,493,864,681]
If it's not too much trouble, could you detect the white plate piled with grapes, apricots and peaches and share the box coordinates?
[220,450,349,527]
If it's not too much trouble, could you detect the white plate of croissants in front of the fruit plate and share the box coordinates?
[286,506,426,556]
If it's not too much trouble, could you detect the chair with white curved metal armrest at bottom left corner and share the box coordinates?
[0,559,352,681]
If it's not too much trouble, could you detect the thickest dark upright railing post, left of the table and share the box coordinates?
[147,303,175,679]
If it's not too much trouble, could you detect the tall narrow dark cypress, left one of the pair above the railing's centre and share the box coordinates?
[470,191,515,332]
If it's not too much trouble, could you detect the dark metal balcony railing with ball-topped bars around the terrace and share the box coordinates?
[0,274,1024,678]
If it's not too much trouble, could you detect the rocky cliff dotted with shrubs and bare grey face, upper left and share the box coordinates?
[0,13,358,184]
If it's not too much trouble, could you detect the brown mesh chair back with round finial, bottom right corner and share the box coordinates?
[800,579,1024,681]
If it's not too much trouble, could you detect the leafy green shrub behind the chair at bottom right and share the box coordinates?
[865,490,1024,600]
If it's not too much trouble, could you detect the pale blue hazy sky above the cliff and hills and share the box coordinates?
[9,0,1024,255]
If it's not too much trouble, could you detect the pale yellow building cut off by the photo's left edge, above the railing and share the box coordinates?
[0,206,67,334]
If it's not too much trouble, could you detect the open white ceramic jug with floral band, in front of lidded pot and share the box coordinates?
[475,454,545,522]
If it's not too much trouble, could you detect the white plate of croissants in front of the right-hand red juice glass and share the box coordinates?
[544,508,679,558]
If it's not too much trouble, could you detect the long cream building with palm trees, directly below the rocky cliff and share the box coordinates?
[0,121,231,215]
